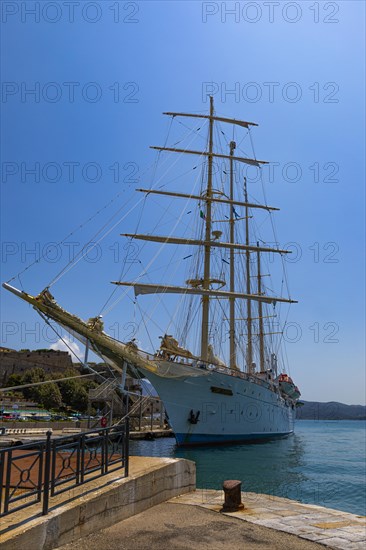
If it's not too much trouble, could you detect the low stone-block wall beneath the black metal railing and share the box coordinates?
[0,457,196,550]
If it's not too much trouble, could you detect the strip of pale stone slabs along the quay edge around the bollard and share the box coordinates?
[170,489,366,550]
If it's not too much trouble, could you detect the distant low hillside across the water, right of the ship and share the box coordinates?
[296,401,366,420]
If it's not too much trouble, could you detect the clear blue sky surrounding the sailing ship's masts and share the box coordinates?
[1,0,365,403]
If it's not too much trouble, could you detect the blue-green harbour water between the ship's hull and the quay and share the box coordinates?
[130,420,366,516]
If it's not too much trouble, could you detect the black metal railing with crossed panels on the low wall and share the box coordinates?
[0,418,129,517]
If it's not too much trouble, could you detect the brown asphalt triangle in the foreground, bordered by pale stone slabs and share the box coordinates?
[58,501,324,550]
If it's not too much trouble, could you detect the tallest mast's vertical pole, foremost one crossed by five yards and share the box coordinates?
[201,96,214,361]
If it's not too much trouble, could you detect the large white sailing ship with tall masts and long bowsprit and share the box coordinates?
[3,97,300,446]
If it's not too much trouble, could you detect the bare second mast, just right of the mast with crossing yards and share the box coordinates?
[229,141,237,369]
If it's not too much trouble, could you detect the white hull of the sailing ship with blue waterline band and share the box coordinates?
[139,368,296,445]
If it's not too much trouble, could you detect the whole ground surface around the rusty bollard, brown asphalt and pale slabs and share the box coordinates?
[58,489,366,550]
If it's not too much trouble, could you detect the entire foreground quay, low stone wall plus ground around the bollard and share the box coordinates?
[0,464,366,550]
